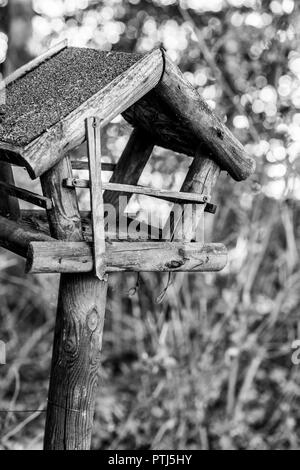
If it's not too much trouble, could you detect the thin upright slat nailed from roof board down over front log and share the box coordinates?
[86,118,105,281]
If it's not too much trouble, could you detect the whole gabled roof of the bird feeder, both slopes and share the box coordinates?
[0,44,254,180]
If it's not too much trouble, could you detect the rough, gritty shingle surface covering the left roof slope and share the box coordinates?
[0,47,141,146]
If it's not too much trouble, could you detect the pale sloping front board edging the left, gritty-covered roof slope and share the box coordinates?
[15,50,163,178]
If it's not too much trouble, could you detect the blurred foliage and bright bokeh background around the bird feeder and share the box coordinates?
[0,0,300,449]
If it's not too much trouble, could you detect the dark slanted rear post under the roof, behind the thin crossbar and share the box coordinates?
[103,129,154,209]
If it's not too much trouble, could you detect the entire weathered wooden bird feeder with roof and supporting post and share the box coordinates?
[0,43,254,449]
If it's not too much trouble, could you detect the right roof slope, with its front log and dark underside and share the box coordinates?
[123,52,255,181]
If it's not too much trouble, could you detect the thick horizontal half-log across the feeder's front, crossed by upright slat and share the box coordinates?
[27,242,227,273]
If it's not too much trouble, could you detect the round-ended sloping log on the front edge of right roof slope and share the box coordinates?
[156,52,255,181]
